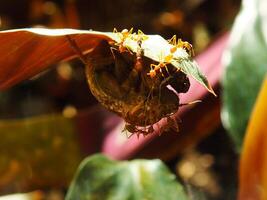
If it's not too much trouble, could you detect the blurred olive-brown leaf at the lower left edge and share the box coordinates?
[0,115,82,193]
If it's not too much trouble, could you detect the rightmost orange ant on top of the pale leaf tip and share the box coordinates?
[168,35,195,57]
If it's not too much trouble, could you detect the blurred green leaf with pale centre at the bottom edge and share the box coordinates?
[66,155,187,200]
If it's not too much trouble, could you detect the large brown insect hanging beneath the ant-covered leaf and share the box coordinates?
[67,30,193,136]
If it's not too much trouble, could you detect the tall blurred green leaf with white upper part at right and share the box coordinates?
[222,0,267,150]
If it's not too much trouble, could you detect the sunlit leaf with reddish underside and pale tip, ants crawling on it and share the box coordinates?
[0,28,213,92]
